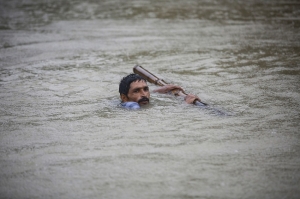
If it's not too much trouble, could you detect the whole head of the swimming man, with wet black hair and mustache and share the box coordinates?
[119,74,150,105]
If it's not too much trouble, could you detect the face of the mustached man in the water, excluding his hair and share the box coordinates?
[121,80,150,106]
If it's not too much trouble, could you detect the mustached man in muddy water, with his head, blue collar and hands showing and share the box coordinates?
[119,74,200,109]
